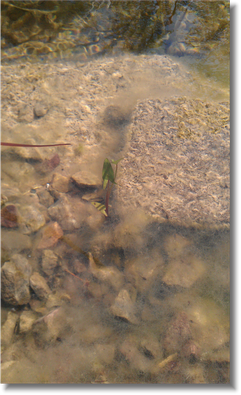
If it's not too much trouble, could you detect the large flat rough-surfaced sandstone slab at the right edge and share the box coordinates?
[116,97,230,227]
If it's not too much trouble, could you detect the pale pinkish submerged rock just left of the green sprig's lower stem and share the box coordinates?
[48,195,88,231]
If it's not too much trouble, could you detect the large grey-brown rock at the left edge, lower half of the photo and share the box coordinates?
[0,254,32,306]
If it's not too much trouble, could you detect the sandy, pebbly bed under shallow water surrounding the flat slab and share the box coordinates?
[0,0,229,383]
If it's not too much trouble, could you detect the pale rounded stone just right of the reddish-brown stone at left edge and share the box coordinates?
[19,206,45,235]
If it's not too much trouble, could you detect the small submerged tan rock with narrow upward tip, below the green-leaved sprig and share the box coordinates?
[89,253,124,291]
